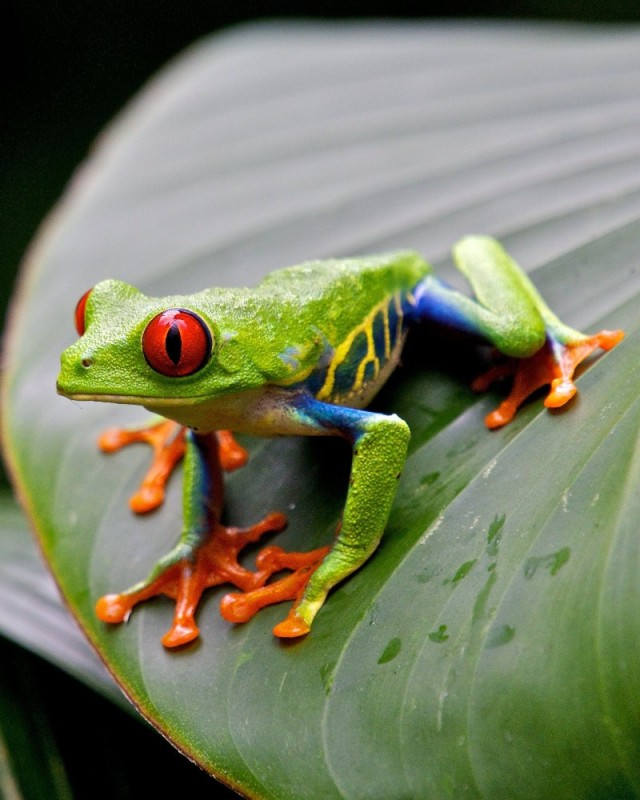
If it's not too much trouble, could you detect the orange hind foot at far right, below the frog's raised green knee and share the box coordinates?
[472,331,624,428]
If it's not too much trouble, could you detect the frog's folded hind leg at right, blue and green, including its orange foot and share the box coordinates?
[412,236,624,428]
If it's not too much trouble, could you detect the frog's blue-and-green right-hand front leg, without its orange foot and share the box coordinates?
[295,398,410,624]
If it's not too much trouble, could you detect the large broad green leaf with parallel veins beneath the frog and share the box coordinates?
[3,25,640,800]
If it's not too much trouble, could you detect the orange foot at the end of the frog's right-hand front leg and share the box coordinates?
[220,545,330,639]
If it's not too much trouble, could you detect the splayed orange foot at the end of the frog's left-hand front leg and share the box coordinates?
[96,513,287,648]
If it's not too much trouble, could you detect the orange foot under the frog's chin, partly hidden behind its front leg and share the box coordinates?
[98,420,248,514]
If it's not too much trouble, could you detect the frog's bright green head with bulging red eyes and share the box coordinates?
[57,280,225,407]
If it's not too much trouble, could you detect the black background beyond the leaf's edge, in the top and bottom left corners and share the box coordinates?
[0,0,640,798]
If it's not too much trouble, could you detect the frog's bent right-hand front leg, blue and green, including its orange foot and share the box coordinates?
[222,395,410,638]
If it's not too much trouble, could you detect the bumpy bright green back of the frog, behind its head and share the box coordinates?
[205,252,430,383]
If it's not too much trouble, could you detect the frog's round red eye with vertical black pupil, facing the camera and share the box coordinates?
[142,308,213,378]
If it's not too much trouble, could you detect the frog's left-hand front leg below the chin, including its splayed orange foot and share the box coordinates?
[96,431,287,647]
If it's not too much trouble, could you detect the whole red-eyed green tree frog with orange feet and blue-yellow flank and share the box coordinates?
[58,236,622,646]
